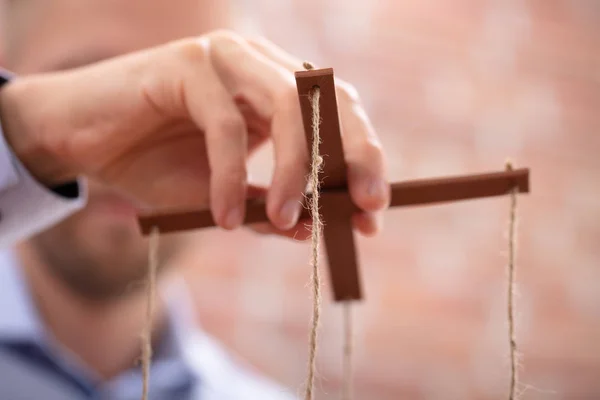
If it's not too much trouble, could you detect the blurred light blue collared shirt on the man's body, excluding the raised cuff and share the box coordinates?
[0,251,296,400]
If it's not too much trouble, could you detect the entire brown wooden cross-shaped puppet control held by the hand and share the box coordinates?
[139,68,529,301]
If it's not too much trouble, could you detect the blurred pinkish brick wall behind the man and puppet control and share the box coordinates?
[2,0,600,400]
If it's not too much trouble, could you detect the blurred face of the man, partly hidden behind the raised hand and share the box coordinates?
[6,0,226,300]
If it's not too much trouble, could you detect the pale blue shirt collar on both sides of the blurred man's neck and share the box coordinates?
[0,250,202,391]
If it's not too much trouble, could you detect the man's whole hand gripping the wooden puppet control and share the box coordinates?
[0,31,390,238]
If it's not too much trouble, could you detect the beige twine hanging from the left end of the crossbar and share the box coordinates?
[142,227,159,400]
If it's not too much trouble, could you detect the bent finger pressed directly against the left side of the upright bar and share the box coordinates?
[205,33,308,230]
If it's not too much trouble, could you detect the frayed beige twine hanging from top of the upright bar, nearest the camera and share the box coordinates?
[304,62,323,400]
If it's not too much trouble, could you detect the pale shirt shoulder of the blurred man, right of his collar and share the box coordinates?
[185,333,298,400]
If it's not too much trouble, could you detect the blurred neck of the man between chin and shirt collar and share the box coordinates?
[17,244,165,380]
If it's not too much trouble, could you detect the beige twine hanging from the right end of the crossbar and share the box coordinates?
[506,161,519,400]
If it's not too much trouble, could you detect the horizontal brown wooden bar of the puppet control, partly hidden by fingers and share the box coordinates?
[138,168,529,234]
